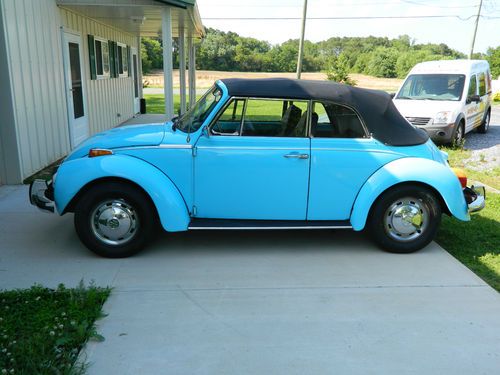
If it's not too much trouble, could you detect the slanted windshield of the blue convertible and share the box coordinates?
[174,86,222,133]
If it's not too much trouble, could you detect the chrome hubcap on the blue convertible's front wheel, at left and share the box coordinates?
[90,199,139,245]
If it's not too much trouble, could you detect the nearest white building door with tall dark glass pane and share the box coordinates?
[62,31,89,148]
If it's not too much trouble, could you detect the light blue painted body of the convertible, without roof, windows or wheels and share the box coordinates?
[54,81,469,232]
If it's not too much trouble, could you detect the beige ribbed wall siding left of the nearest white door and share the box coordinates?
[0,0,69,177]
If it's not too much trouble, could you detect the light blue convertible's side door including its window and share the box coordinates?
[194,98,310,220]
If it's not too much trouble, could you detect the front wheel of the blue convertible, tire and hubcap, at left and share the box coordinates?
[74,182,157,258]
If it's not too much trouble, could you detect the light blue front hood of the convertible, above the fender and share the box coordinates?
[66,124,165,160]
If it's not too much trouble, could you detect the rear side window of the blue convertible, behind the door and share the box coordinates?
[311,101,366,138]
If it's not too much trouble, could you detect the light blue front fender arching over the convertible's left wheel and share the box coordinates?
[54,154,190,232]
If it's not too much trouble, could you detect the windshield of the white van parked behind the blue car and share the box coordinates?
[396,74,465,100]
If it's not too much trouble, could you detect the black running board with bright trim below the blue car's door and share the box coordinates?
[188,218,352,230]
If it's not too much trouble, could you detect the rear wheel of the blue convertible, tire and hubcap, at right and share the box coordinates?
[367,185,441,253]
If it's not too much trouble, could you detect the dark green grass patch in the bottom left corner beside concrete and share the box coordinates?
[0,283,110,375]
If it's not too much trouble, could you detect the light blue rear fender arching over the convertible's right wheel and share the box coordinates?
[351,157,470,231]
